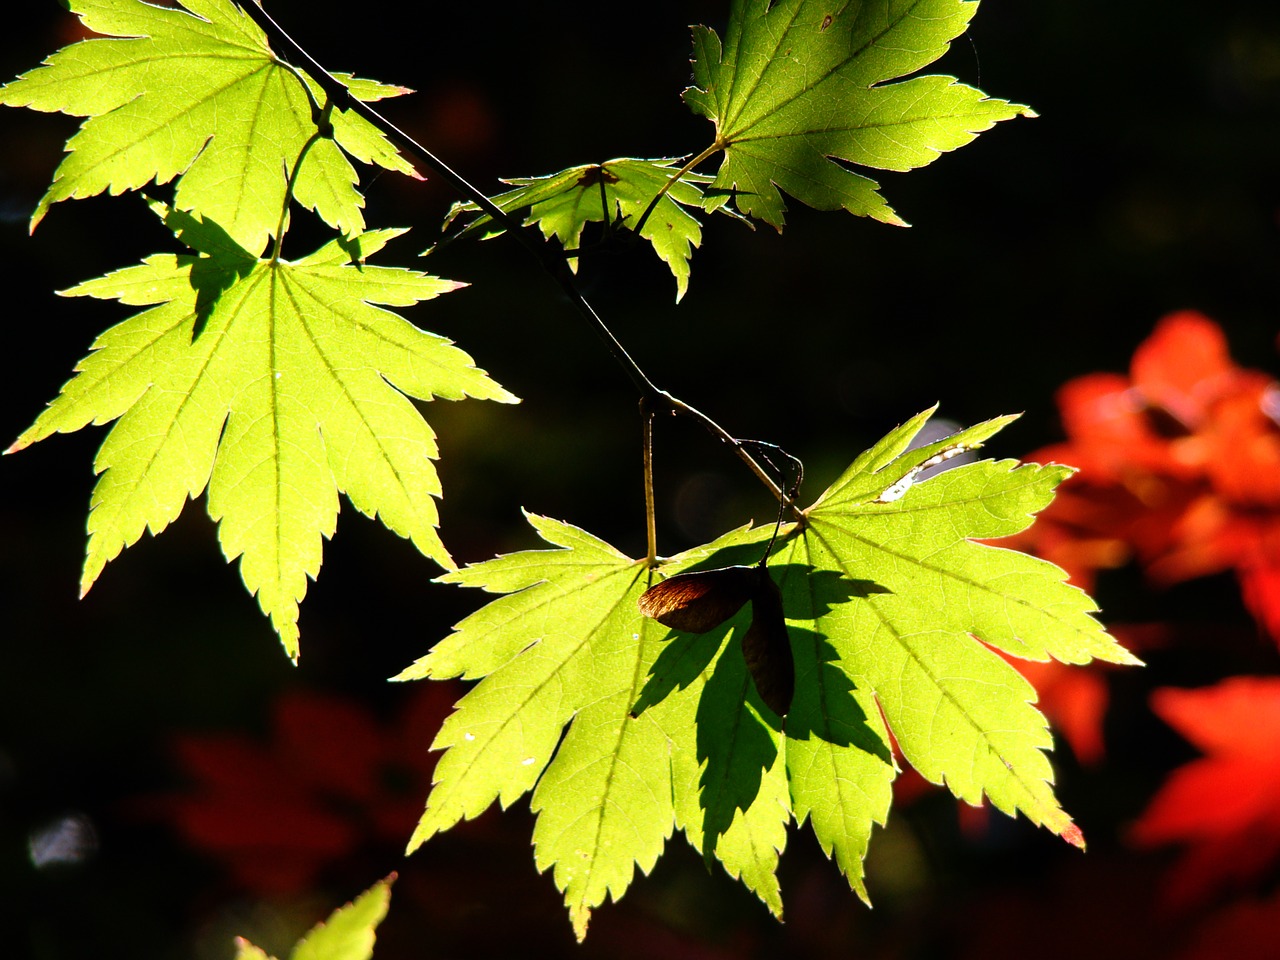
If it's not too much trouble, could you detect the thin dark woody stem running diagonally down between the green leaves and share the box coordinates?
[238,0,799,516]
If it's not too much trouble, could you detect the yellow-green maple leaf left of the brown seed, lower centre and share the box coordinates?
[397,516,787,938]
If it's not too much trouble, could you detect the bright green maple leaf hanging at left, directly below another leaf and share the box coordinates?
[9,209,515,658]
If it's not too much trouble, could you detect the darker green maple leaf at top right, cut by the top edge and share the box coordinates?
[685,0,1034,229]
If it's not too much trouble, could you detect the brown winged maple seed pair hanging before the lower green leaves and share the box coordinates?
[637,564,795,717]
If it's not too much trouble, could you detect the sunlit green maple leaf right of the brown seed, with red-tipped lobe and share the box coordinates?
[788,412,1138,845]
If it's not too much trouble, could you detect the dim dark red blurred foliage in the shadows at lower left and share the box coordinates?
[148,684,458,895]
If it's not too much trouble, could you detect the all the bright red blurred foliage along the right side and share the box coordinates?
[1004,311,1280,960]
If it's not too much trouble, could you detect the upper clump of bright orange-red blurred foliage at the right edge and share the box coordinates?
[1015,311,1280,641]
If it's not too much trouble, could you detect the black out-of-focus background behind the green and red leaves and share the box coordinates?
[0,0,1280,960]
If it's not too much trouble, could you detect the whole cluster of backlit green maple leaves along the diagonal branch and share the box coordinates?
[0,0,1134,942]
